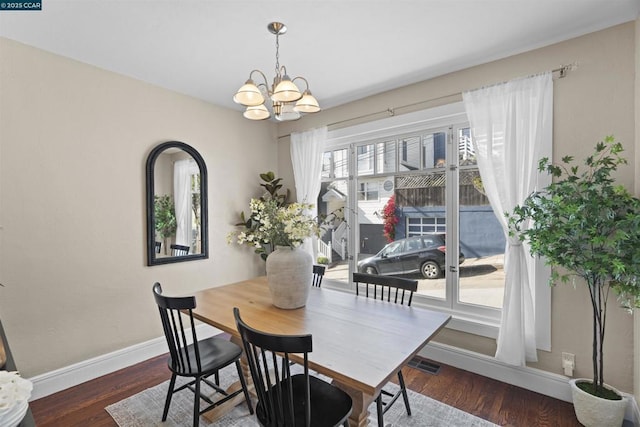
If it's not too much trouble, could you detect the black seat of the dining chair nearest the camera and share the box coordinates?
[256,374,352,427]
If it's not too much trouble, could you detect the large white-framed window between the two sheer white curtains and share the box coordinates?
[321,123,505,319]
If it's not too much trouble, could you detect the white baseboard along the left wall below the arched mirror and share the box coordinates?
[29,324,221,401]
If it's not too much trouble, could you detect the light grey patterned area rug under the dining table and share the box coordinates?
[105,369,497,427]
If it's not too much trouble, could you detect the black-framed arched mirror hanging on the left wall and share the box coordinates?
[147,141,209,265]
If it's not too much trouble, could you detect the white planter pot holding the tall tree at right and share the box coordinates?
[569,378,628,427]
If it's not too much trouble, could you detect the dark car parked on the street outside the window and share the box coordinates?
[358,233,464,279]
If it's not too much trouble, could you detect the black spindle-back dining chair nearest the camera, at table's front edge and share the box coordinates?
[233,307,352,427]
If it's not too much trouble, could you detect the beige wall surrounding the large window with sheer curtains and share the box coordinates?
[278,23,638,392]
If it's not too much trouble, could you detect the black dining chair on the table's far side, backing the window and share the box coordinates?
[353,273,418,427]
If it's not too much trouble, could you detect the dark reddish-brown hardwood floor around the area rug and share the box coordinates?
[31,355,580,427]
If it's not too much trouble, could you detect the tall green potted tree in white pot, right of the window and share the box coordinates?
[506,136,640,427]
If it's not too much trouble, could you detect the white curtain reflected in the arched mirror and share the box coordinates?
[173,159,200,247]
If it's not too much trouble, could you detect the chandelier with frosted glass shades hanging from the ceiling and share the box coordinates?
[233,22,320,121]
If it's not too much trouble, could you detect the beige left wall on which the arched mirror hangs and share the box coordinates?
[0,38,278,377]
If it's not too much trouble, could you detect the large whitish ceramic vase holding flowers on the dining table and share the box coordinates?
[267,246,313,309]
